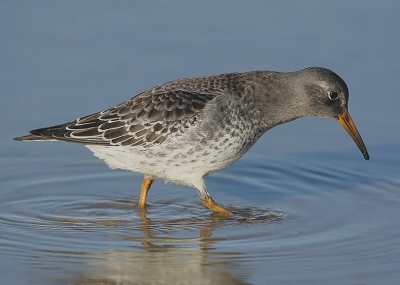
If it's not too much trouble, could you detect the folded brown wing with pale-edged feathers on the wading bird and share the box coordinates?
[16,90,215,147]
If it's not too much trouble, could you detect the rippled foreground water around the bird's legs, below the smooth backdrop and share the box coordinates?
[0,142,400,284]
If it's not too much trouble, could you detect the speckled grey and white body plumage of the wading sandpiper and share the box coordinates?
[15,67,368,213]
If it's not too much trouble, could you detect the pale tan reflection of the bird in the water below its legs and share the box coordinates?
[69,203,281,285]
